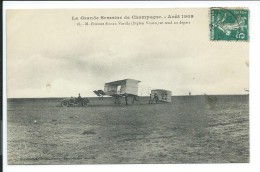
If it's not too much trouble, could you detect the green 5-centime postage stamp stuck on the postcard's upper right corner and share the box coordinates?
[210,8,249,41]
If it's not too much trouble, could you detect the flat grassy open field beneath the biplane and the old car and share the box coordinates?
[7,95,249,164]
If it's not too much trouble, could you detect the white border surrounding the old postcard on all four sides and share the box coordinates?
[3,1,260,172]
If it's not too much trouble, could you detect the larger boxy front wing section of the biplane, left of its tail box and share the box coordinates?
[93,79,141,105]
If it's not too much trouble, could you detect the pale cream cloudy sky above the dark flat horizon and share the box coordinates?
[6,9,249,98]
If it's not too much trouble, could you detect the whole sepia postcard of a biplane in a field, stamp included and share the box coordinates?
[6,6,251,165]
